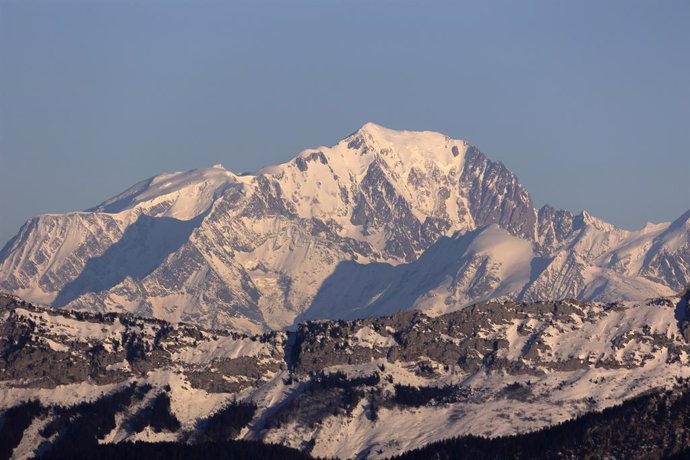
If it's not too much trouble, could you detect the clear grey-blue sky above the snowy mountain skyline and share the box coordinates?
[0,0,690,244]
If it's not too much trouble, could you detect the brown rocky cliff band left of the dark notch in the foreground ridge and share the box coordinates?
[0,296,286,393]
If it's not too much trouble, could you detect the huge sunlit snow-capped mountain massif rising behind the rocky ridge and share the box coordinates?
[0,123,690,331]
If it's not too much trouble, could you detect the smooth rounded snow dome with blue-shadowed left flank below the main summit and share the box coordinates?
[300,224,534,320]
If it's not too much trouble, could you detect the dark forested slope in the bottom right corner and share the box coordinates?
[391,383,690,460]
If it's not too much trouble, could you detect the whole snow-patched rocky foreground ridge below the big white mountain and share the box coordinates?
[0,295,690,458]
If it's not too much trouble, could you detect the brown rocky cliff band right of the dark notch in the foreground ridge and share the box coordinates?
[296,298,686,375]
